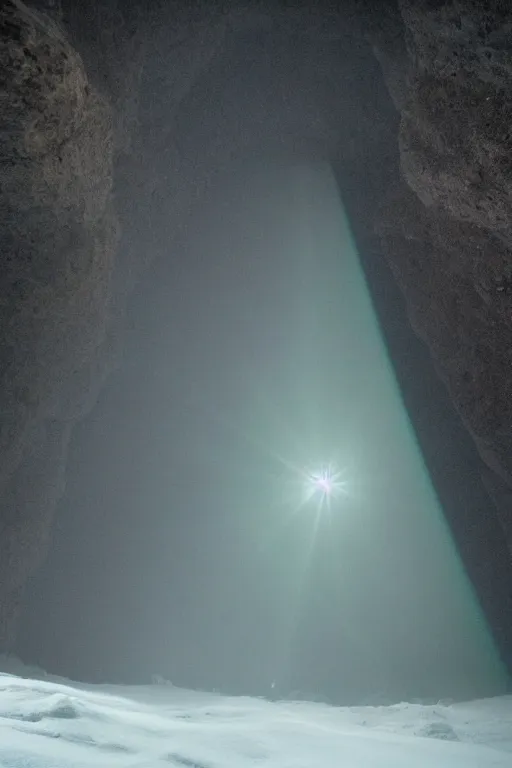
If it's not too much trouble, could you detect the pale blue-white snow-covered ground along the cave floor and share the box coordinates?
[0,660,512,768]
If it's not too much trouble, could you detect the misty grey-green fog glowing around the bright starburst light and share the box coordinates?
[19,164,504,703]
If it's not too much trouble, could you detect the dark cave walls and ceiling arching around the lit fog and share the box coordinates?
[0,0,512,660]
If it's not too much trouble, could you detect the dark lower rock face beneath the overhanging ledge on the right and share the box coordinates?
[379,185,512,476]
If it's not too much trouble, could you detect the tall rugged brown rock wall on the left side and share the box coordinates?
[0,1,117,644]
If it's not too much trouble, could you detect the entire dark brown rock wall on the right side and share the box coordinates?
[372,0,512,549]
